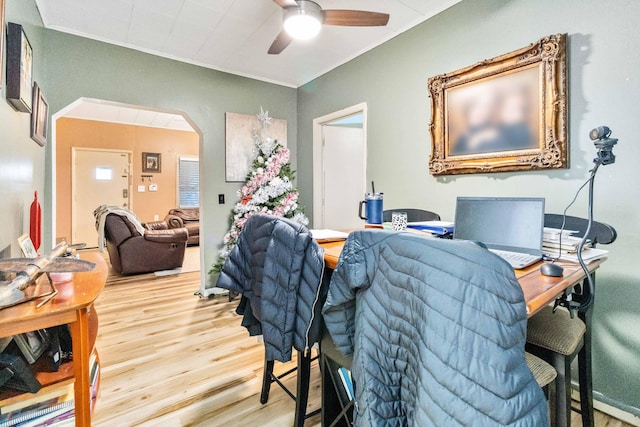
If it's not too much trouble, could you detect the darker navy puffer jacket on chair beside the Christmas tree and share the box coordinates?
[216,214,327,362]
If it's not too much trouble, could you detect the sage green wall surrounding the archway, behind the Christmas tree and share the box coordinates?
[40,30,297,287]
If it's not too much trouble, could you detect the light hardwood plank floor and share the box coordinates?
[93,256,628,427]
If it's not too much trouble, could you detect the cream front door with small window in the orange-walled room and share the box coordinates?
[71,148,131,247]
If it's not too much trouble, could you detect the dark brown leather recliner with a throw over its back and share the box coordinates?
[104,213,189,274]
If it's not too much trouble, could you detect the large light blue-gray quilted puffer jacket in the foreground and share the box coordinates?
[323,230,548,427]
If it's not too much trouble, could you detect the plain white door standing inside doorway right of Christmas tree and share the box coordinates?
[322,126,366,230]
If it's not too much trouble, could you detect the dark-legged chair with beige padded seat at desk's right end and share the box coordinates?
[527,214,617,427]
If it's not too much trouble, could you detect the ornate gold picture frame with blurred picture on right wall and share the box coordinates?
[428,34,568,175]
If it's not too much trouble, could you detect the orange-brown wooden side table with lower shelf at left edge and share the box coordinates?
[0,253,108,426]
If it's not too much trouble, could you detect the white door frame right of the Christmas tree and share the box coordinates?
[312,102,367,228]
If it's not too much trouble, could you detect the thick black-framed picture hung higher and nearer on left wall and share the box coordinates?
[6,22,33,113]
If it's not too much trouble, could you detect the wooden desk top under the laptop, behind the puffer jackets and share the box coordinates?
[320,241,606,317]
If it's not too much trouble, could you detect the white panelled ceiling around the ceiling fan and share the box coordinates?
[35,0,460,87]
